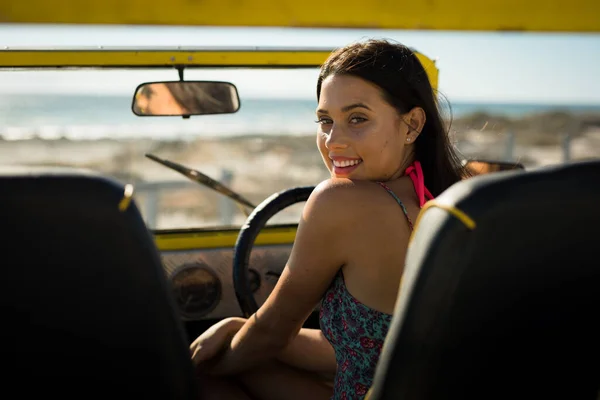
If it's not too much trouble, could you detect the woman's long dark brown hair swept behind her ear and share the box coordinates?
[317,39,466,196]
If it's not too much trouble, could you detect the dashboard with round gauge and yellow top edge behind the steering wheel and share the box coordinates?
[159,226,296,321]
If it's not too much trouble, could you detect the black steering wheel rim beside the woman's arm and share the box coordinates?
[233,186,315,318]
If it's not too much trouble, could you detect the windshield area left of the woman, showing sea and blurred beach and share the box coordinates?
[0,69,328,229]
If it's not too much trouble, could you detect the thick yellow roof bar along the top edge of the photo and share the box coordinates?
[0,0,600,32]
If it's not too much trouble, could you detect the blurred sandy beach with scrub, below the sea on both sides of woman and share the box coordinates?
[0,112,600,229]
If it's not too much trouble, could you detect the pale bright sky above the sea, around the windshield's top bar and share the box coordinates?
[0,24,600,105]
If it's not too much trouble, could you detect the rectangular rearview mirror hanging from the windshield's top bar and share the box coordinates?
[131,81,240,116]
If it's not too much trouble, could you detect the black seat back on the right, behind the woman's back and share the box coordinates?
[369,161,600,400]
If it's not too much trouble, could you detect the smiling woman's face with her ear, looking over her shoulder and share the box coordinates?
[317,75,424,181]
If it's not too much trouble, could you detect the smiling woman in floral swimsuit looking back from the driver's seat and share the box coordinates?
[191,40,463,399]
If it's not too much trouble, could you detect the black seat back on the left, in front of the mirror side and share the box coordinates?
[0,170,196,399]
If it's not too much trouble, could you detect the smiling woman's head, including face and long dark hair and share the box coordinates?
[317,41,463,195]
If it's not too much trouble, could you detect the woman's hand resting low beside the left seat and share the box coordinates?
[190,318,246,367]
